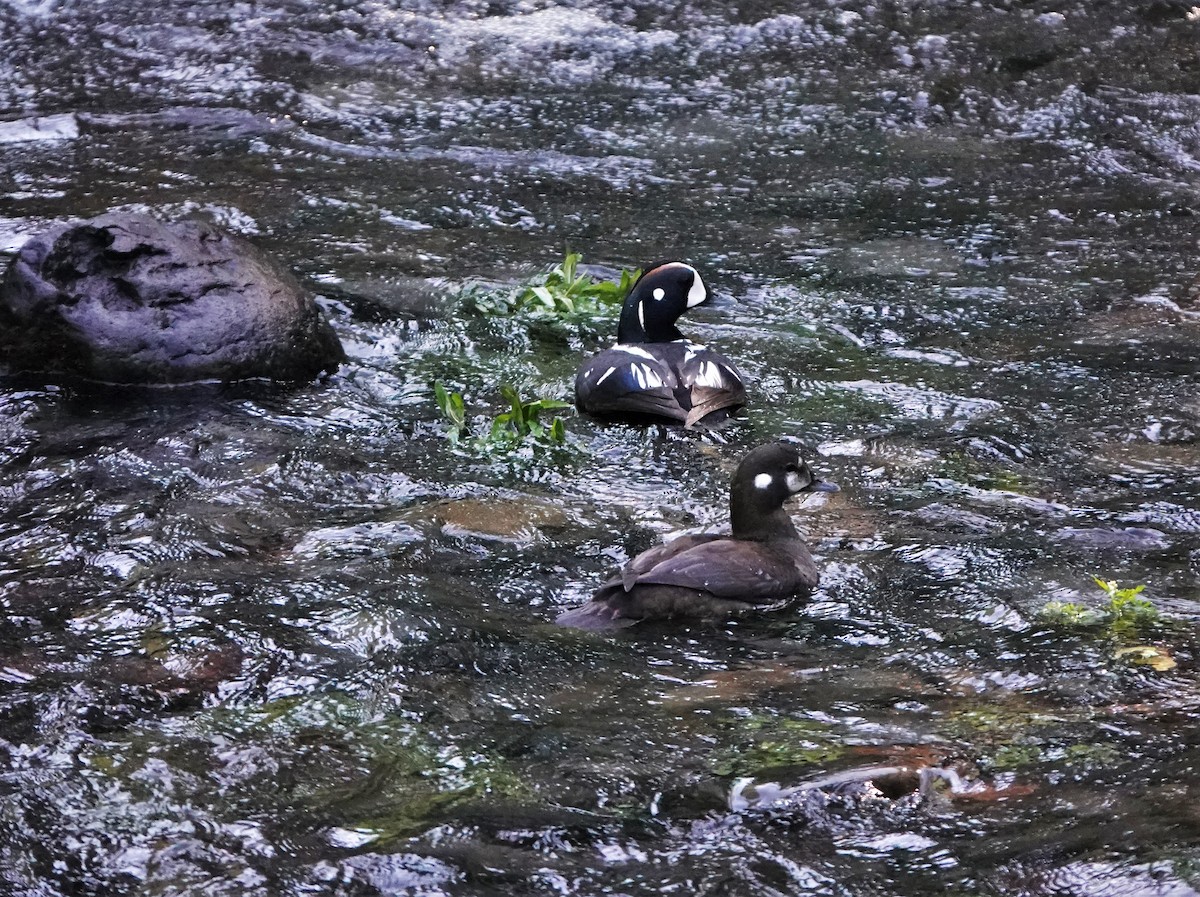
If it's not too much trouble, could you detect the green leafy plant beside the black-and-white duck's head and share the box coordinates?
[473,252,640,318]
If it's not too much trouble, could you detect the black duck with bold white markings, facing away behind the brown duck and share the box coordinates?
[575,261,746,427]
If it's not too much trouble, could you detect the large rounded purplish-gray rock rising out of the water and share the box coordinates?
[0,212,346,384]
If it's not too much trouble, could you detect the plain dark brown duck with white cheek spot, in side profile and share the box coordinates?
[558,443,838,630]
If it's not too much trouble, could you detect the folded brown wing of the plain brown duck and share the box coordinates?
[626,538,817,603]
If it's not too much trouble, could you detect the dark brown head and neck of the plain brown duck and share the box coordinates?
[730,443,838,541]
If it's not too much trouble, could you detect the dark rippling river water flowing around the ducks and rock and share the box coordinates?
[0,0,1200,897]
